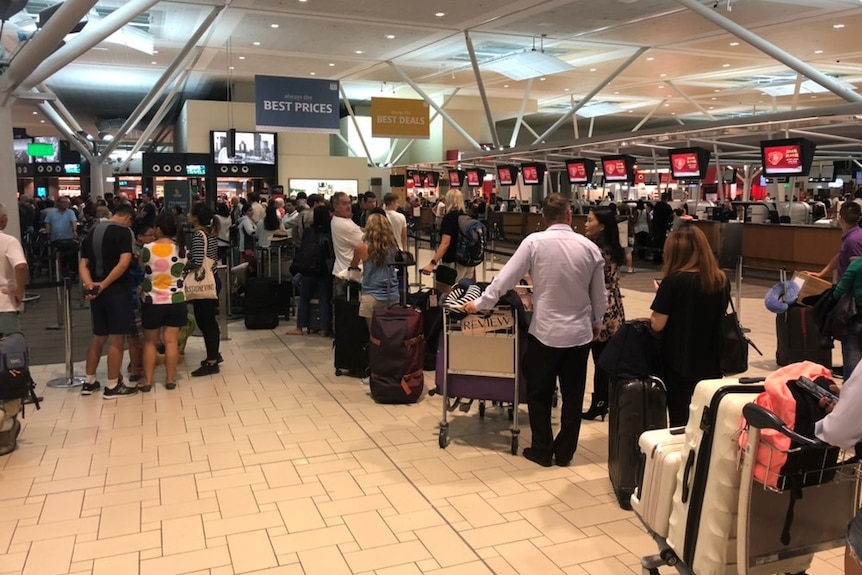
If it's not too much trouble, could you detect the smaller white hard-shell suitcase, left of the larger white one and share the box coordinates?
[631,427,685,537]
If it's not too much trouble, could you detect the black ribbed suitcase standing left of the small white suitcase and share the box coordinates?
[608,377,667,509]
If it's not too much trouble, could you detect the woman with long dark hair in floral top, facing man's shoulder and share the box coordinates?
[581,206,626,421]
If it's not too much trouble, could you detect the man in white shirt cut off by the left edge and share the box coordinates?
[0,204,30,455]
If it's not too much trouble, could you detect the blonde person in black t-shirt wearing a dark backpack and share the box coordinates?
[421,189,485,286]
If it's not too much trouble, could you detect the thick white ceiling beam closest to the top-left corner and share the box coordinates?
[0,0,97,104]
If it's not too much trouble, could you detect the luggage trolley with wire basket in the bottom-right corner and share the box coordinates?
[736,403,860,575]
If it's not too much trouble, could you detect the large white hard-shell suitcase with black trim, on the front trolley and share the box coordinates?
[667,379,811,575]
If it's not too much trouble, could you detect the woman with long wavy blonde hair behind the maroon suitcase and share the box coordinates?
[350,208,399,385]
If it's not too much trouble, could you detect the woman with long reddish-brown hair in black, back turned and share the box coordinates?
[649,223,730,427]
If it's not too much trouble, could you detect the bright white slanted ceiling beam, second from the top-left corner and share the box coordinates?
[22,0,165,88]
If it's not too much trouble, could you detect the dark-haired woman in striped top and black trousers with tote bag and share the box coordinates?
[188,203,223,377]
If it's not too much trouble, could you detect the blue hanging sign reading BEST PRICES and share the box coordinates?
[254,76,341,134]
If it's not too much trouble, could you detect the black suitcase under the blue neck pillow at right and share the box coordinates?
[775,305,832,368]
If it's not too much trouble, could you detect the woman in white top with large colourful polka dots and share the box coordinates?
[138,213,188,392]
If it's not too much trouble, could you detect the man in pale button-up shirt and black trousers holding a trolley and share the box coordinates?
[464,194,608,467]
